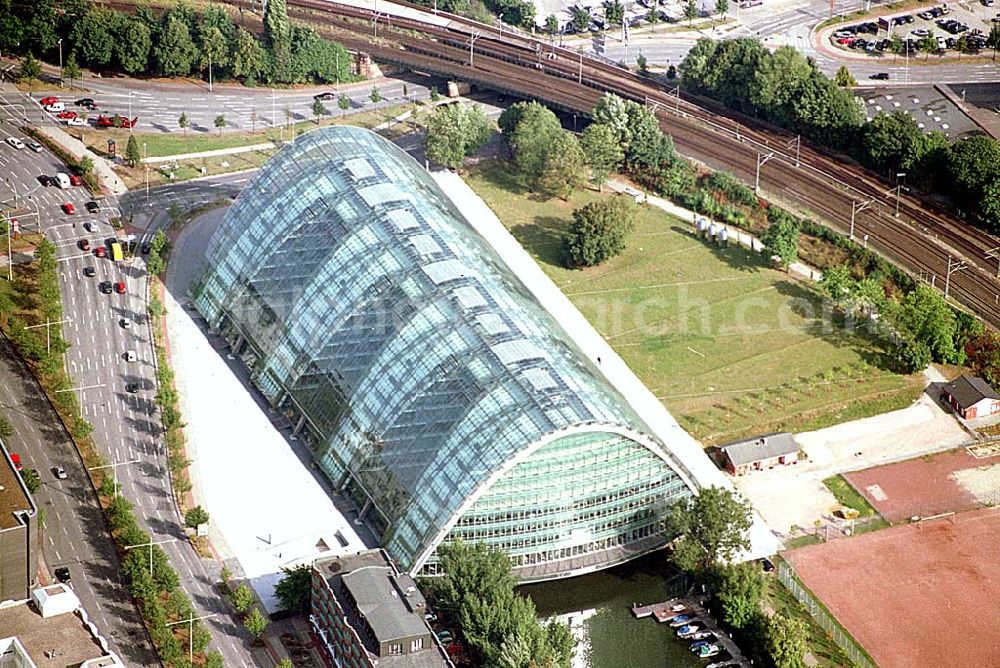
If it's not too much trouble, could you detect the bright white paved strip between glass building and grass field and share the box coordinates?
[432,171,781,558]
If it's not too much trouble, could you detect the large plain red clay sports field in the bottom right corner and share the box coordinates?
[784,508,1000,668]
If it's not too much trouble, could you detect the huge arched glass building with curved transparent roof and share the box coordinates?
[194,127,696,581]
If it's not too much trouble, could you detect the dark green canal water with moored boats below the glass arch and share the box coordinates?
[520,552,708,668]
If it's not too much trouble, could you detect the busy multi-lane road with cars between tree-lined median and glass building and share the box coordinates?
[0,126,257,666]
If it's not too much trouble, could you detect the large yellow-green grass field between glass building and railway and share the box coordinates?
[467,162,922,444]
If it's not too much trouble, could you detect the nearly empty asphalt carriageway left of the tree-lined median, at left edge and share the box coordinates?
[0,337,159,666]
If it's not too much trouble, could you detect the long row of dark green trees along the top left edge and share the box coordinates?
[0,0,356,85]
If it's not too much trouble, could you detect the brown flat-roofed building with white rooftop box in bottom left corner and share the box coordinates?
[0,584,125,668]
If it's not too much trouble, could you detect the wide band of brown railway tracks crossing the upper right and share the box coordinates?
[230,0,1000,326]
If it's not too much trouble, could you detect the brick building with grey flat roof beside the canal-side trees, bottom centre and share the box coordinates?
[309,550,453,668]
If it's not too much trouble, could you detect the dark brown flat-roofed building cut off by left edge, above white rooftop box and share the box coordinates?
[0,441,38,603]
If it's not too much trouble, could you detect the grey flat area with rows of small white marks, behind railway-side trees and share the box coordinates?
[858,86,980,139]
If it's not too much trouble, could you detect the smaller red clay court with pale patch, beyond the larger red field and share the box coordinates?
[844,448,1000,523]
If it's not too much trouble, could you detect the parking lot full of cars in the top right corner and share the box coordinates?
[830,0,1000,57]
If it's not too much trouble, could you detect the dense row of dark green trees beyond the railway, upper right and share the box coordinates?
[680,39,1000,232]
